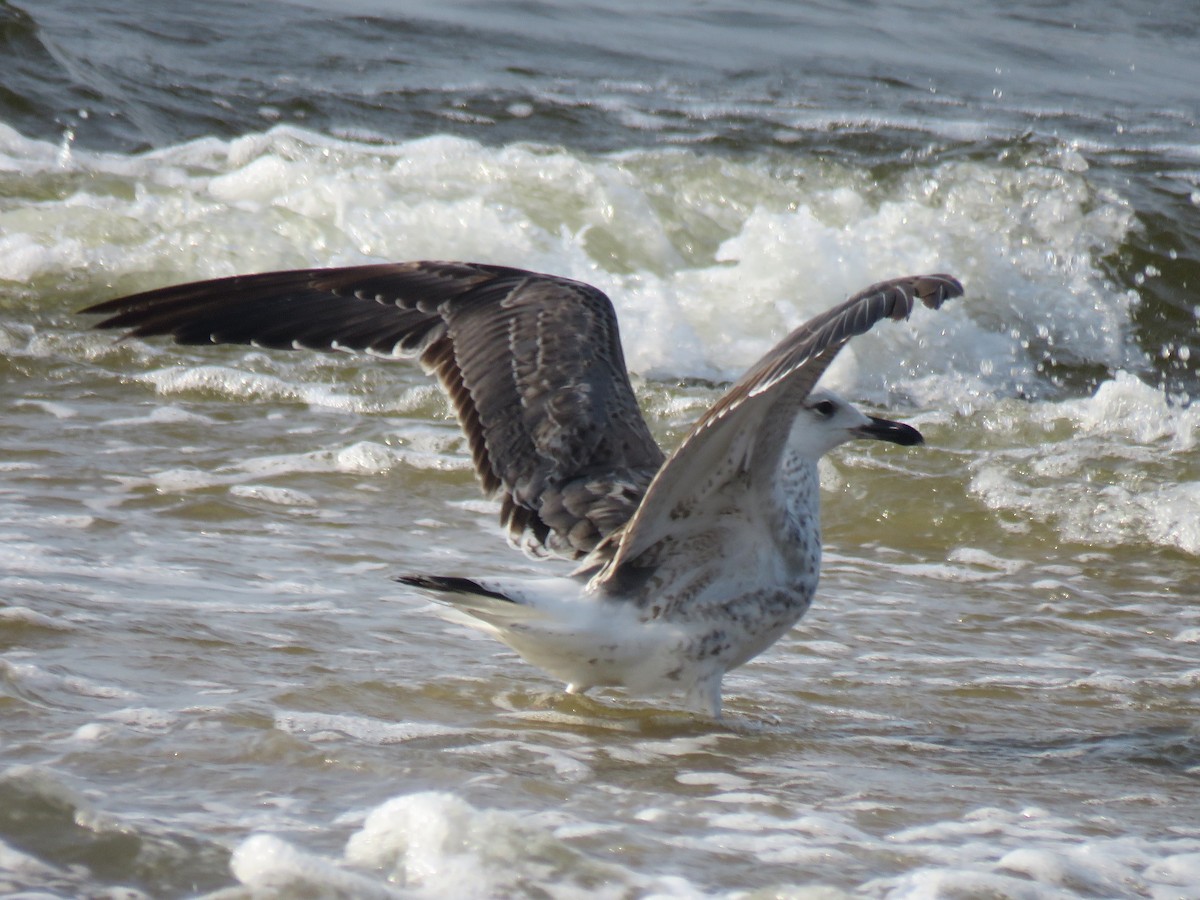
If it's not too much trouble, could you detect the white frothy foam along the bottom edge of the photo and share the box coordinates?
[223,792,1200,900]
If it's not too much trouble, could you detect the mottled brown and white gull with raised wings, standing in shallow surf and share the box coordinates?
[84,260,962,719]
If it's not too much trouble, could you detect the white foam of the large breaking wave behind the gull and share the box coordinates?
[0,126,1140,406]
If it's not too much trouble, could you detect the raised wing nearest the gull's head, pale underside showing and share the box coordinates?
[600,275,962,583]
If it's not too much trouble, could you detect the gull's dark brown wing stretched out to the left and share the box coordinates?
[83,262,664,557]
